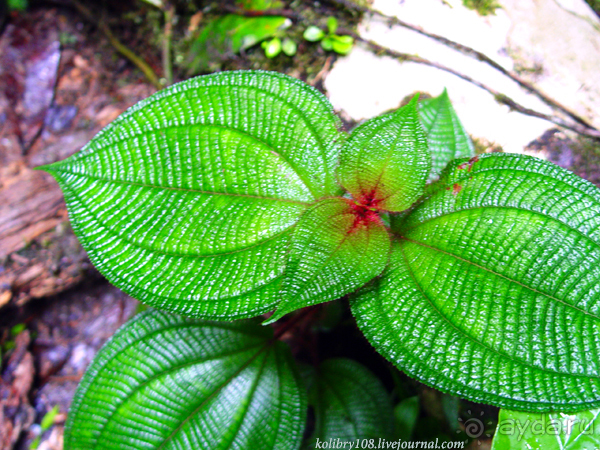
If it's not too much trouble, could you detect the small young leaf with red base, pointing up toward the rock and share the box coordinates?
[338,97,431,211]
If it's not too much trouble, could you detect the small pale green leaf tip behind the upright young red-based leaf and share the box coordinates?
[419,89,475,180]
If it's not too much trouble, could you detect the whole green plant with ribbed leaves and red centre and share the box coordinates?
[42,71,600,449]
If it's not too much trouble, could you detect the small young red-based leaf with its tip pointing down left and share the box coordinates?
[268,198,390,323]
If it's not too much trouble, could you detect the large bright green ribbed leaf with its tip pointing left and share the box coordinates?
[44,72,342,319]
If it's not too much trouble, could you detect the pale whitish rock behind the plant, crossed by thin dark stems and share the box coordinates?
[324,0,600,152]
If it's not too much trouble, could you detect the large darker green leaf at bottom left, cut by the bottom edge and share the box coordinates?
[65,311,307,450]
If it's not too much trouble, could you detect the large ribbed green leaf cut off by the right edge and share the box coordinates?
[352,154,600,412]
